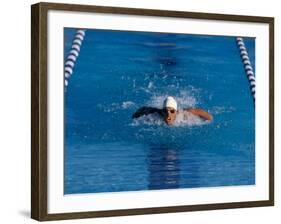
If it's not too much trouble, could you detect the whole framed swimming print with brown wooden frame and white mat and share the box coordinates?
[31,3,274,221]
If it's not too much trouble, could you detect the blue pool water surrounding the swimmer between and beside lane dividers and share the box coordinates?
[64,28,255,194]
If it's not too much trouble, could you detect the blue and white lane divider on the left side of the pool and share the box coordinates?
[64,29,86,86]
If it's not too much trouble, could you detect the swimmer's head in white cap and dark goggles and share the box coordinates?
[163,96,178,125]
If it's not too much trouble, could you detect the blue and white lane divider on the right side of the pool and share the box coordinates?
[236,37,256,102]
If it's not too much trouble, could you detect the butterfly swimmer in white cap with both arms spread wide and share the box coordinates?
[132,96,213,125]
